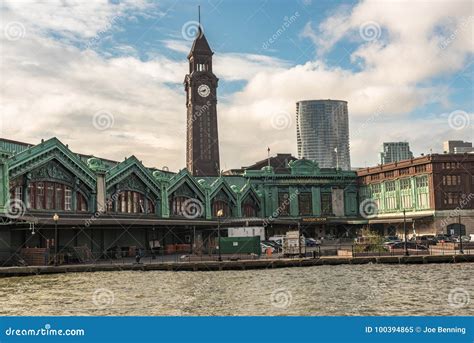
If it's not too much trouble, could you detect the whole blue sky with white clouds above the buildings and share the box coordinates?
[0,0,474,170]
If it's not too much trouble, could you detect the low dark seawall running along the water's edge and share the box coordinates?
[0,255,474,277]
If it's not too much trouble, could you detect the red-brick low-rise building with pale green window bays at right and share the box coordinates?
[357,154,474,236]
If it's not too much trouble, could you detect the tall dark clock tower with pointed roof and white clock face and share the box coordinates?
[184,27,220,176]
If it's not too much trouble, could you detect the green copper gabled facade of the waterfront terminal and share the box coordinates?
[0,138,358,221]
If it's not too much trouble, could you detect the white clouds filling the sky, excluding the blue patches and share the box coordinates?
[0,1,474,170]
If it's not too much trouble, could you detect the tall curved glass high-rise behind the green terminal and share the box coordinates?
[296,99,351,170]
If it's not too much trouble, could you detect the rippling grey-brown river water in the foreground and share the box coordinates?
[0,263,474,316]
